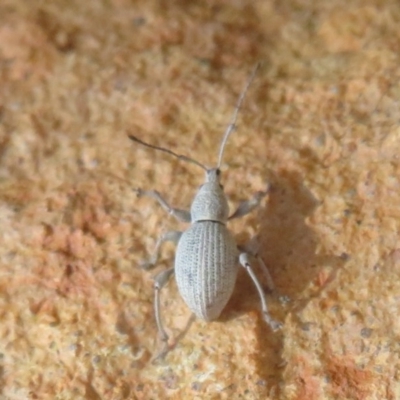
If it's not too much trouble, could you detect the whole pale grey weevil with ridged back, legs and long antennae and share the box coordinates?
[128,65,281,354]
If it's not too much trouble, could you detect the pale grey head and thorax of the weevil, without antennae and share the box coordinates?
[190,168,229,224]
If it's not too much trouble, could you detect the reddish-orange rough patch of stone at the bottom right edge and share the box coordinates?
[327,356,373,400]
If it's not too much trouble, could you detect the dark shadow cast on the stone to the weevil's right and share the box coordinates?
[220,171,345,387]
